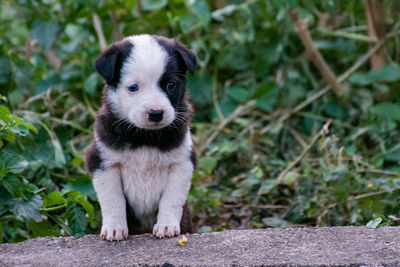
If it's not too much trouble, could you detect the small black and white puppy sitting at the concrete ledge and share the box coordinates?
[86,35,196,241]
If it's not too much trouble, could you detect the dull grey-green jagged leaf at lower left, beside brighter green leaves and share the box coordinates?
[12,195,43,221]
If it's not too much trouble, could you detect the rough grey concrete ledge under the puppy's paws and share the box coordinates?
[0,227,400,266]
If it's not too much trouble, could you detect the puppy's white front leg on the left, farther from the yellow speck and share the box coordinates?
[93,167,128,241]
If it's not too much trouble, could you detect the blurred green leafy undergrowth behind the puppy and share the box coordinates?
[0,0,400,242]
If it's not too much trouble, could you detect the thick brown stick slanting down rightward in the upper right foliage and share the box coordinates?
[289,9,343,97]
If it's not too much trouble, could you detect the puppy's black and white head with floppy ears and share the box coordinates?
[95,35,196,129]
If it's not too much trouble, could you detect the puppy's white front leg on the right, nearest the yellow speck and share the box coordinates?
[153,161,193,238]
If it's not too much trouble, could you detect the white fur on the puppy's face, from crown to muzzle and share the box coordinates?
[106,35,175,129]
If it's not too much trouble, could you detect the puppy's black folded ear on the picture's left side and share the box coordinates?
[94,40,133,86]
